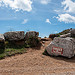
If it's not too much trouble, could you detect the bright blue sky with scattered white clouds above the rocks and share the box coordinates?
[0,0,75,37]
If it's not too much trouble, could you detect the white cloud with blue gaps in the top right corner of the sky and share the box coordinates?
[62,0,75,14]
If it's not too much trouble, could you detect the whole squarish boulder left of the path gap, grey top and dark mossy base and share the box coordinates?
[25,31,40,47]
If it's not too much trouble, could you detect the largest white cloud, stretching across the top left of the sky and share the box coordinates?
[0,0,32,12]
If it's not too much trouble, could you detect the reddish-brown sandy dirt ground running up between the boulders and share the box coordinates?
[0,41,75,75]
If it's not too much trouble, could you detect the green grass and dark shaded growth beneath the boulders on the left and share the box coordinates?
[0,37,40,59]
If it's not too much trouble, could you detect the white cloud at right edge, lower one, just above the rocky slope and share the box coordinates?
[56,14,75,23]
